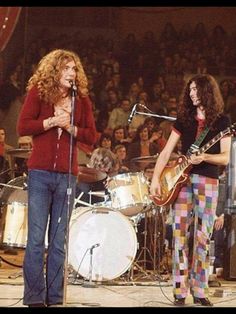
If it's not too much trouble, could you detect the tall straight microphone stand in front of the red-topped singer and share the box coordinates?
[63,83,76,306]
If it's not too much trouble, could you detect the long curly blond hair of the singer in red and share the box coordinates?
[26,49,88,104]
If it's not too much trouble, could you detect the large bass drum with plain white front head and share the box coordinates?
[68,207,137,281]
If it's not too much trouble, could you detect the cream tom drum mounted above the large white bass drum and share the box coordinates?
[108,172,151,216]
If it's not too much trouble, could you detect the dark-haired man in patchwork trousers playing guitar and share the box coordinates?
[150,75,231,306]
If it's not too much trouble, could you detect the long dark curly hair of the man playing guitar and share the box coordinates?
[178,74,224,128]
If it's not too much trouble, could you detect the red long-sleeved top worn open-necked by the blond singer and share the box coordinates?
[17,87,96,175]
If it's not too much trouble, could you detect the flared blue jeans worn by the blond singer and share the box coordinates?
[23,170,76,304]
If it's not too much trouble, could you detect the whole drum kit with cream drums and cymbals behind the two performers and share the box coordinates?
[0,149,166,282]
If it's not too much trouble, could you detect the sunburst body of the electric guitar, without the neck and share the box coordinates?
[150,155,191,206]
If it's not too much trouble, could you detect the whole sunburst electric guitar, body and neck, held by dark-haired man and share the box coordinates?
[150,122,236,206]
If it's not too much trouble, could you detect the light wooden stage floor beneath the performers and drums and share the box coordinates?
[0,249,236,308]
